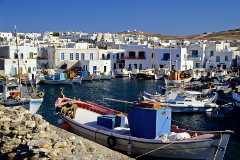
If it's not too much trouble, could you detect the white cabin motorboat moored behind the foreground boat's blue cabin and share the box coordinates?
[161,91,218,112]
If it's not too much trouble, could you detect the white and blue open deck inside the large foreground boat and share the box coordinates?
[73,108,131,136]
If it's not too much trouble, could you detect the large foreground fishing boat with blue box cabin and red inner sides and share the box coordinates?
[55,89,233,159]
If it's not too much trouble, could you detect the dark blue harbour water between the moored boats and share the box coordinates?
[0,78,240,160]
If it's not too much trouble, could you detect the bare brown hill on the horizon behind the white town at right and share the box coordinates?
[116,28,240,41]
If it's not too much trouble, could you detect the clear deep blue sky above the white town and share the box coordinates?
[0,0,240,36]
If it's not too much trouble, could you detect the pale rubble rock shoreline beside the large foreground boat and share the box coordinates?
[0,105,132,160]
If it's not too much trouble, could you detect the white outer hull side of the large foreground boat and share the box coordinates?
[59,114,225,159]
